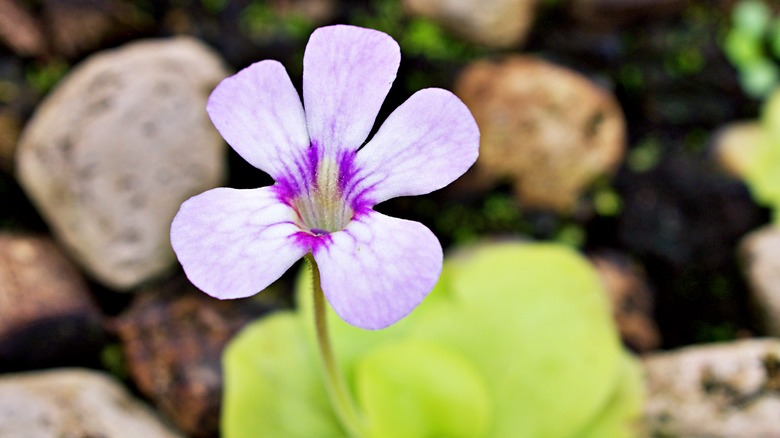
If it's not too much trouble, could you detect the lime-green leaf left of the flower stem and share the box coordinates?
[222,312,346,438]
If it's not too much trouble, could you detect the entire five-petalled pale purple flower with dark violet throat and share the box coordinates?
[171,26,479,329]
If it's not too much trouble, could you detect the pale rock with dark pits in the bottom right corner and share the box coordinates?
[644,339,780,438]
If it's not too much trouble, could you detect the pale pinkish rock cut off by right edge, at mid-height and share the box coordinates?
[739,226,780,336]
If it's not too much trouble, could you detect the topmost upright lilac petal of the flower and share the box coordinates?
[303,25,401,152]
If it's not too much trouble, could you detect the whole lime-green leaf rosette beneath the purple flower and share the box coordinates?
[223,243,641,438]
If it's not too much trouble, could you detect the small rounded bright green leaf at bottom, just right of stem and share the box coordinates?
[356,340,490,438]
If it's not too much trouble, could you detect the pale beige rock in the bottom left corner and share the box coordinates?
[0,369,181,438]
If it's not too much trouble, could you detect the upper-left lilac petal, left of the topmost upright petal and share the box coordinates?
[206,60,309,179]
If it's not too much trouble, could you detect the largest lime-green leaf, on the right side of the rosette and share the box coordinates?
[412,243,621,438]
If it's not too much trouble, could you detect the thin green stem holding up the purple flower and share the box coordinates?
[306,254,365,438]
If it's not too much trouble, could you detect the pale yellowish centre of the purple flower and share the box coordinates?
[293,158,354,235]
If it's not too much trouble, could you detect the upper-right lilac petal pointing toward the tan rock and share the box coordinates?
[346,88,479,204]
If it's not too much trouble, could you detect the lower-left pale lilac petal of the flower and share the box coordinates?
[171,187,308,299]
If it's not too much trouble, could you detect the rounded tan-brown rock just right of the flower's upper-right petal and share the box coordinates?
[455,55,626,213]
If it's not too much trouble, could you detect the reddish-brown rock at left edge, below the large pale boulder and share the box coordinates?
[0,233,104,370]
